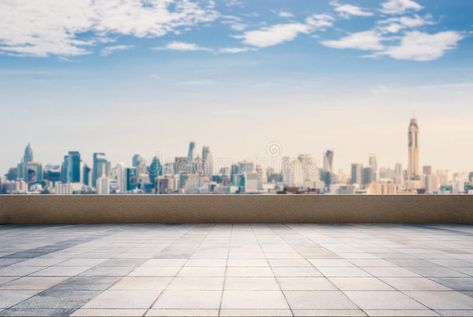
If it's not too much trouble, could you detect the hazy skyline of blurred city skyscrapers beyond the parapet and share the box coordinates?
[0,119,473,195]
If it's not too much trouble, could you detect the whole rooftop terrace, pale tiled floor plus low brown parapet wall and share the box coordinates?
[0,196,473,316]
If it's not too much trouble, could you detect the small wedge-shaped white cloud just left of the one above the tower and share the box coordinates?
[321,31,384,50]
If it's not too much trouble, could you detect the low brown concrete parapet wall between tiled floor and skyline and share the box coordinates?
[0,195,473,224]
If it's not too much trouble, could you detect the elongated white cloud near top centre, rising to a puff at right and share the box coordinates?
[241,14,333,47]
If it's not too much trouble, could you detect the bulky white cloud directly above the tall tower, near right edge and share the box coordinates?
[377,31,463,62]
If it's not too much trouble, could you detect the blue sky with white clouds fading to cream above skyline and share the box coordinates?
[0,0,473,171]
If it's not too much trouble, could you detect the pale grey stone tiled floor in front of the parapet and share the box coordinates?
[0,224,473,316]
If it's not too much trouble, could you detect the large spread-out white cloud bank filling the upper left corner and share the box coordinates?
[0,0,217,56]
